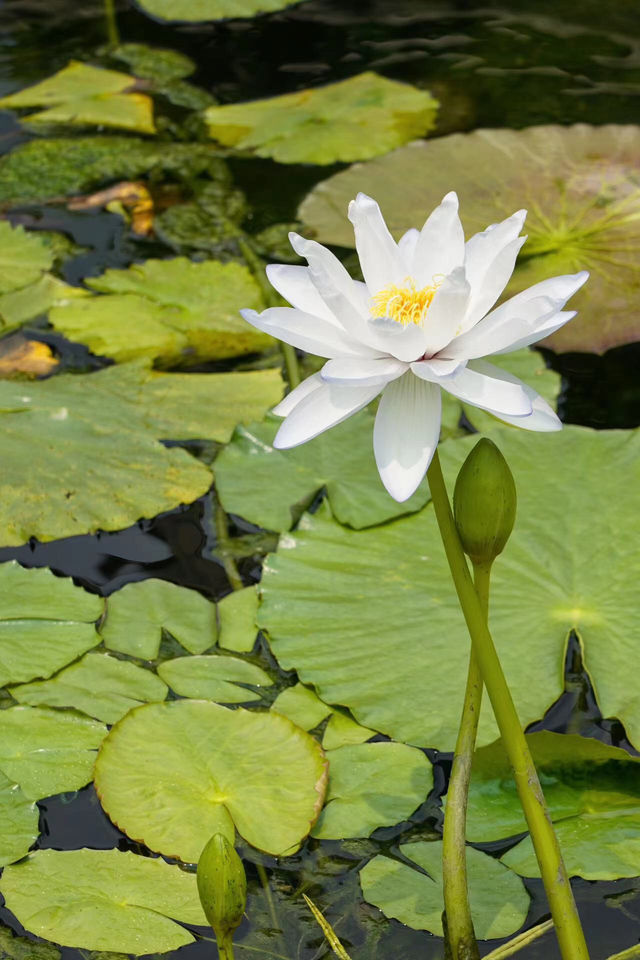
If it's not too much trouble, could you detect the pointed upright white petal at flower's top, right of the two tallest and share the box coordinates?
[413,193,464,287]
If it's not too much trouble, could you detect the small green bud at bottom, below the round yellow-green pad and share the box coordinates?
[197,833,247,943]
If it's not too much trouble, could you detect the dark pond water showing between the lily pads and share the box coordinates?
[0,0,640,960]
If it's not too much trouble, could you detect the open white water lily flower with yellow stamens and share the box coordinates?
[242,193,588,501]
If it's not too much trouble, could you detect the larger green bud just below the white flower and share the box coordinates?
[453,437,517,564]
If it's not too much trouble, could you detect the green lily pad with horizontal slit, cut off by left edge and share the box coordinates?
[0,560,104,686]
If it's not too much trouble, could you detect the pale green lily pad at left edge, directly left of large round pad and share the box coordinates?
[0,707,107,800]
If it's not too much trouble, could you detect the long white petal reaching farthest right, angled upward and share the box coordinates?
[442,270,589,360]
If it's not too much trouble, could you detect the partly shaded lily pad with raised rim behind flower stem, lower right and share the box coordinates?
[467,731,640,880]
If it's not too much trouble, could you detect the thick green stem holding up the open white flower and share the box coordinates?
[427,451,589,960]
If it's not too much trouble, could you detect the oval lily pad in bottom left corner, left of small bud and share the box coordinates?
[0,850,206,956]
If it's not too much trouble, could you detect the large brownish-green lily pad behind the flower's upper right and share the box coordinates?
[299,124,640,353]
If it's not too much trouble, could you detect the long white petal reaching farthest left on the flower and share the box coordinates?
[240,307,378,357]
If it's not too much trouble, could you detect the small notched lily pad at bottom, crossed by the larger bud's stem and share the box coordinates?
[360,840,529,940]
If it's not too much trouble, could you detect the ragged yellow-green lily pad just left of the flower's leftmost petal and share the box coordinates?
[49,257,273,366]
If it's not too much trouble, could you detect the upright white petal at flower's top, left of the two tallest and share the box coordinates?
[348,193,405,296]
